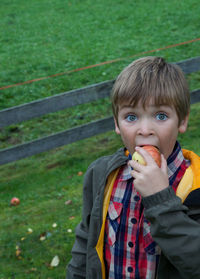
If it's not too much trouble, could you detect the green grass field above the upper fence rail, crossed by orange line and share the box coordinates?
[0,0,200,108]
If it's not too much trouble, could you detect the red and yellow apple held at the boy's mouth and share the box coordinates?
[132,145,161,168]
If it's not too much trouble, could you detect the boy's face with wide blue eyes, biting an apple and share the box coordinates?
[115,102,188,159]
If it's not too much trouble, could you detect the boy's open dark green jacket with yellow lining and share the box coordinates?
[67,149,200,279]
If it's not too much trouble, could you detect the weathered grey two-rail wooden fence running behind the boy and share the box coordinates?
[0,57,200,165]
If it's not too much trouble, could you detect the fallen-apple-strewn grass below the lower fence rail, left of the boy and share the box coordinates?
[0,134,122,278]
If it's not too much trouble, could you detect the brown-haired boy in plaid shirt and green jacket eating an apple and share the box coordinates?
[67,57,200,279]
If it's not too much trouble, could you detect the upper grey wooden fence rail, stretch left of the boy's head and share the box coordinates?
[0,80,114,128]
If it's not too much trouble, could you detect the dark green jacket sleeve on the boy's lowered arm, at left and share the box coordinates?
[66,164,93,279]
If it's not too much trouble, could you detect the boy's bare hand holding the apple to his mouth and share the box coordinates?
[129,147,169,197]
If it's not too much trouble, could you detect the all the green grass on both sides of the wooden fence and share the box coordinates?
[0,0,200,279]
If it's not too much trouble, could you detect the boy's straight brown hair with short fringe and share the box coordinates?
[111,56,190,123]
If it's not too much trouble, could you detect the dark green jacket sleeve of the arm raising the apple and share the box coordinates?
[143,187,200,279]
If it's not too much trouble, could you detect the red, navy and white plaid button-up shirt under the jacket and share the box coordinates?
[104,142,189,279]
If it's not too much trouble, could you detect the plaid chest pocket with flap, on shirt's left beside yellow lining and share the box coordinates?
[107,201,123,246]
